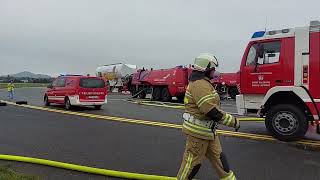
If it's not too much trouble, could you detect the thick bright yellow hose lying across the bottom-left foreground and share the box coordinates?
[0,154,176,180]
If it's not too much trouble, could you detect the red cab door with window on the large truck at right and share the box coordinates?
[240,39,287,94]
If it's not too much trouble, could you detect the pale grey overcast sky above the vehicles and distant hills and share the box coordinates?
[0,0,320,75]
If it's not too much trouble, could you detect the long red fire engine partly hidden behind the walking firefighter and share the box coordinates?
[129,66,239,101]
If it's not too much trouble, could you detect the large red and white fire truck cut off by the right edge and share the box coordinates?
[236,21,320,141]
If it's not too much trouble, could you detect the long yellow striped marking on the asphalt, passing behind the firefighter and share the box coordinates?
[2,101,320,148]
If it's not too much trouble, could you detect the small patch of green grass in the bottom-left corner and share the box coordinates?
[0,166,40,180]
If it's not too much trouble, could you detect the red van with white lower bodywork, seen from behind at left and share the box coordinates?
[44,75,107,110]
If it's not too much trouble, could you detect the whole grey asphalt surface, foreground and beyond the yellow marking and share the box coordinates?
[0,88,320,180]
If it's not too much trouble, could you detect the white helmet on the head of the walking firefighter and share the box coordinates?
[192,53,219,72]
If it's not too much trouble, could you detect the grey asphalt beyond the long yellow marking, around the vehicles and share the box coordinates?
[0,88,320,140]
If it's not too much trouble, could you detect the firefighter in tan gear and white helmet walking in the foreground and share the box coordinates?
[177,54,240,180]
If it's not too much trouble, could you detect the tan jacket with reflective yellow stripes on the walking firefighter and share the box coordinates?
[182,71,236,139]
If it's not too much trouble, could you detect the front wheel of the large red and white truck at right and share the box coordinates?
[265,104,308,141]
